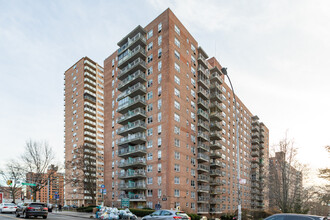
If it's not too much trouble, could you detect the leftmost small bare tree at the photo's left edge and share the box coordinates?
[0,160,24,203]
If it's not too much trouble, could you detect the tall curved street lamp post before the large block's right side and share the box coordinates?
[221,67,242,220]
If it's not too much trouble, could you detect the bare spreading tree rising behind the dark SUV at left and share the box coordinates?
[21,140,56,201]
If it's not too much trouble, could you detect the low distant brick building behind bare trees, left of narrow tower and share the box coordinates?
[26,165,64,205]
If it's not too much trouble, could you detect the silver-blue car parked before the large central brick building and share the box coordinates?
[142,210,190,220]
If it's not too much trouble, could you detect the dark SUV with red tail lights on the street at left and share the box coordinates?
[15,202,48,219]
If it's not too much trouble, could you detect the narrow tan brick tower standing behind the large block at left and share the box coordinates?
[64,57,104,206]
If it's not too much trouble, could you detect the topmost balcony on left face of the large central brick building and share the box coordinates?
[118,30,147,55]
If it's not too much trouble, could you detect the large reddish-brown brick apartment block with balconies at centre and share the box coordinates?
[104,9,268,216]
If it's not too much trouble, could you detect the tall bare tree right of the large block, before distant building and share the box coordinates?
[269,135,307,213]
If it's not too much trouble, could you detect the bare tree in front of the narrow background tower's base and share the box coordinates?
[65,144,96,205]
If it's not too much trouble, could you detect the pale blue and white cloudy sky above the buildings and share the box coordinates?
[0,0,330,186]
